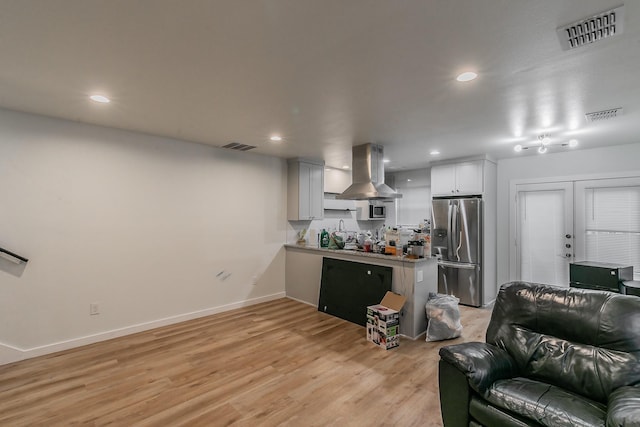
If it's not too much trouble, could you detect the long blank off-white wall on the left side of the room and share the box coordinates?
[0,110,287,363]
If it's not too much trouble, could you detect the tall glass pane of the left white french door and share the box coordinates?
[518,190,569,286]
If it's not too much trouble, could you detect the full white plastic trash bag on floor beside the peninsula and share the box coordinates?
[425,292,462,341]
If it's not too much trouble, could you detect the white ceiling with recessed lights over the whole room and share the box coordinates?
[0,0,640,170]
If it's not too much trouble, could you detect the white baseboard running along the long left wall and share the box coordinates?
[0,292,285,365]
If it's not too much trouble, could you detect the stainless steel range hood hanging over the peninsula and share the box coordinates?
[336,144,402,200]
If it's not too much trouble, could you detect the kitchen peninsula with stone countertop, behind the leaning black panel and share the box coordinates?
[285,244,438,339]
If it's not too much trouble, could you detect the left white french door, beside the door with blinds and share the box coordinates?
[510,182,574,286]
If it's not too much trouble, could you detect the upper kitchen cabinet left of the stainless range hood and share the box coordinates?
[287,159,324,221]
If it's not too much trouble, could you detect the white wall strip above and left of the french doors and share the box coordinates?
[497,144,640,285]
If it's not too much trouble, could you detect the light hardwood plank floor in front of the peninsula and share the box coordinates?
[0,298,490,426]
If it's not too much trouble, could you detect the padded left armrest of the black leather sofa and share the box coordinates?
[440,342,518,394]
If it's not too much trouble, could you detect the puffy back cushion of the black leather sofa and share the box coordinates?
[487,282,640,403]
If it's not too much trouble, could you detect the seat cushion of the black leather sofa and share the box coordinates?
[485,377,607,427]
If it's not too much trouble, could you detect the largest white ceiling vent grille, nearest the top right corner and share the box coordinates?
[556,5,624,50]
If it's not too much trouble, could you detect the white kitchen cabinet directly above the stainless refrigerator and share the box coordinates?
[431,160,484,196]
